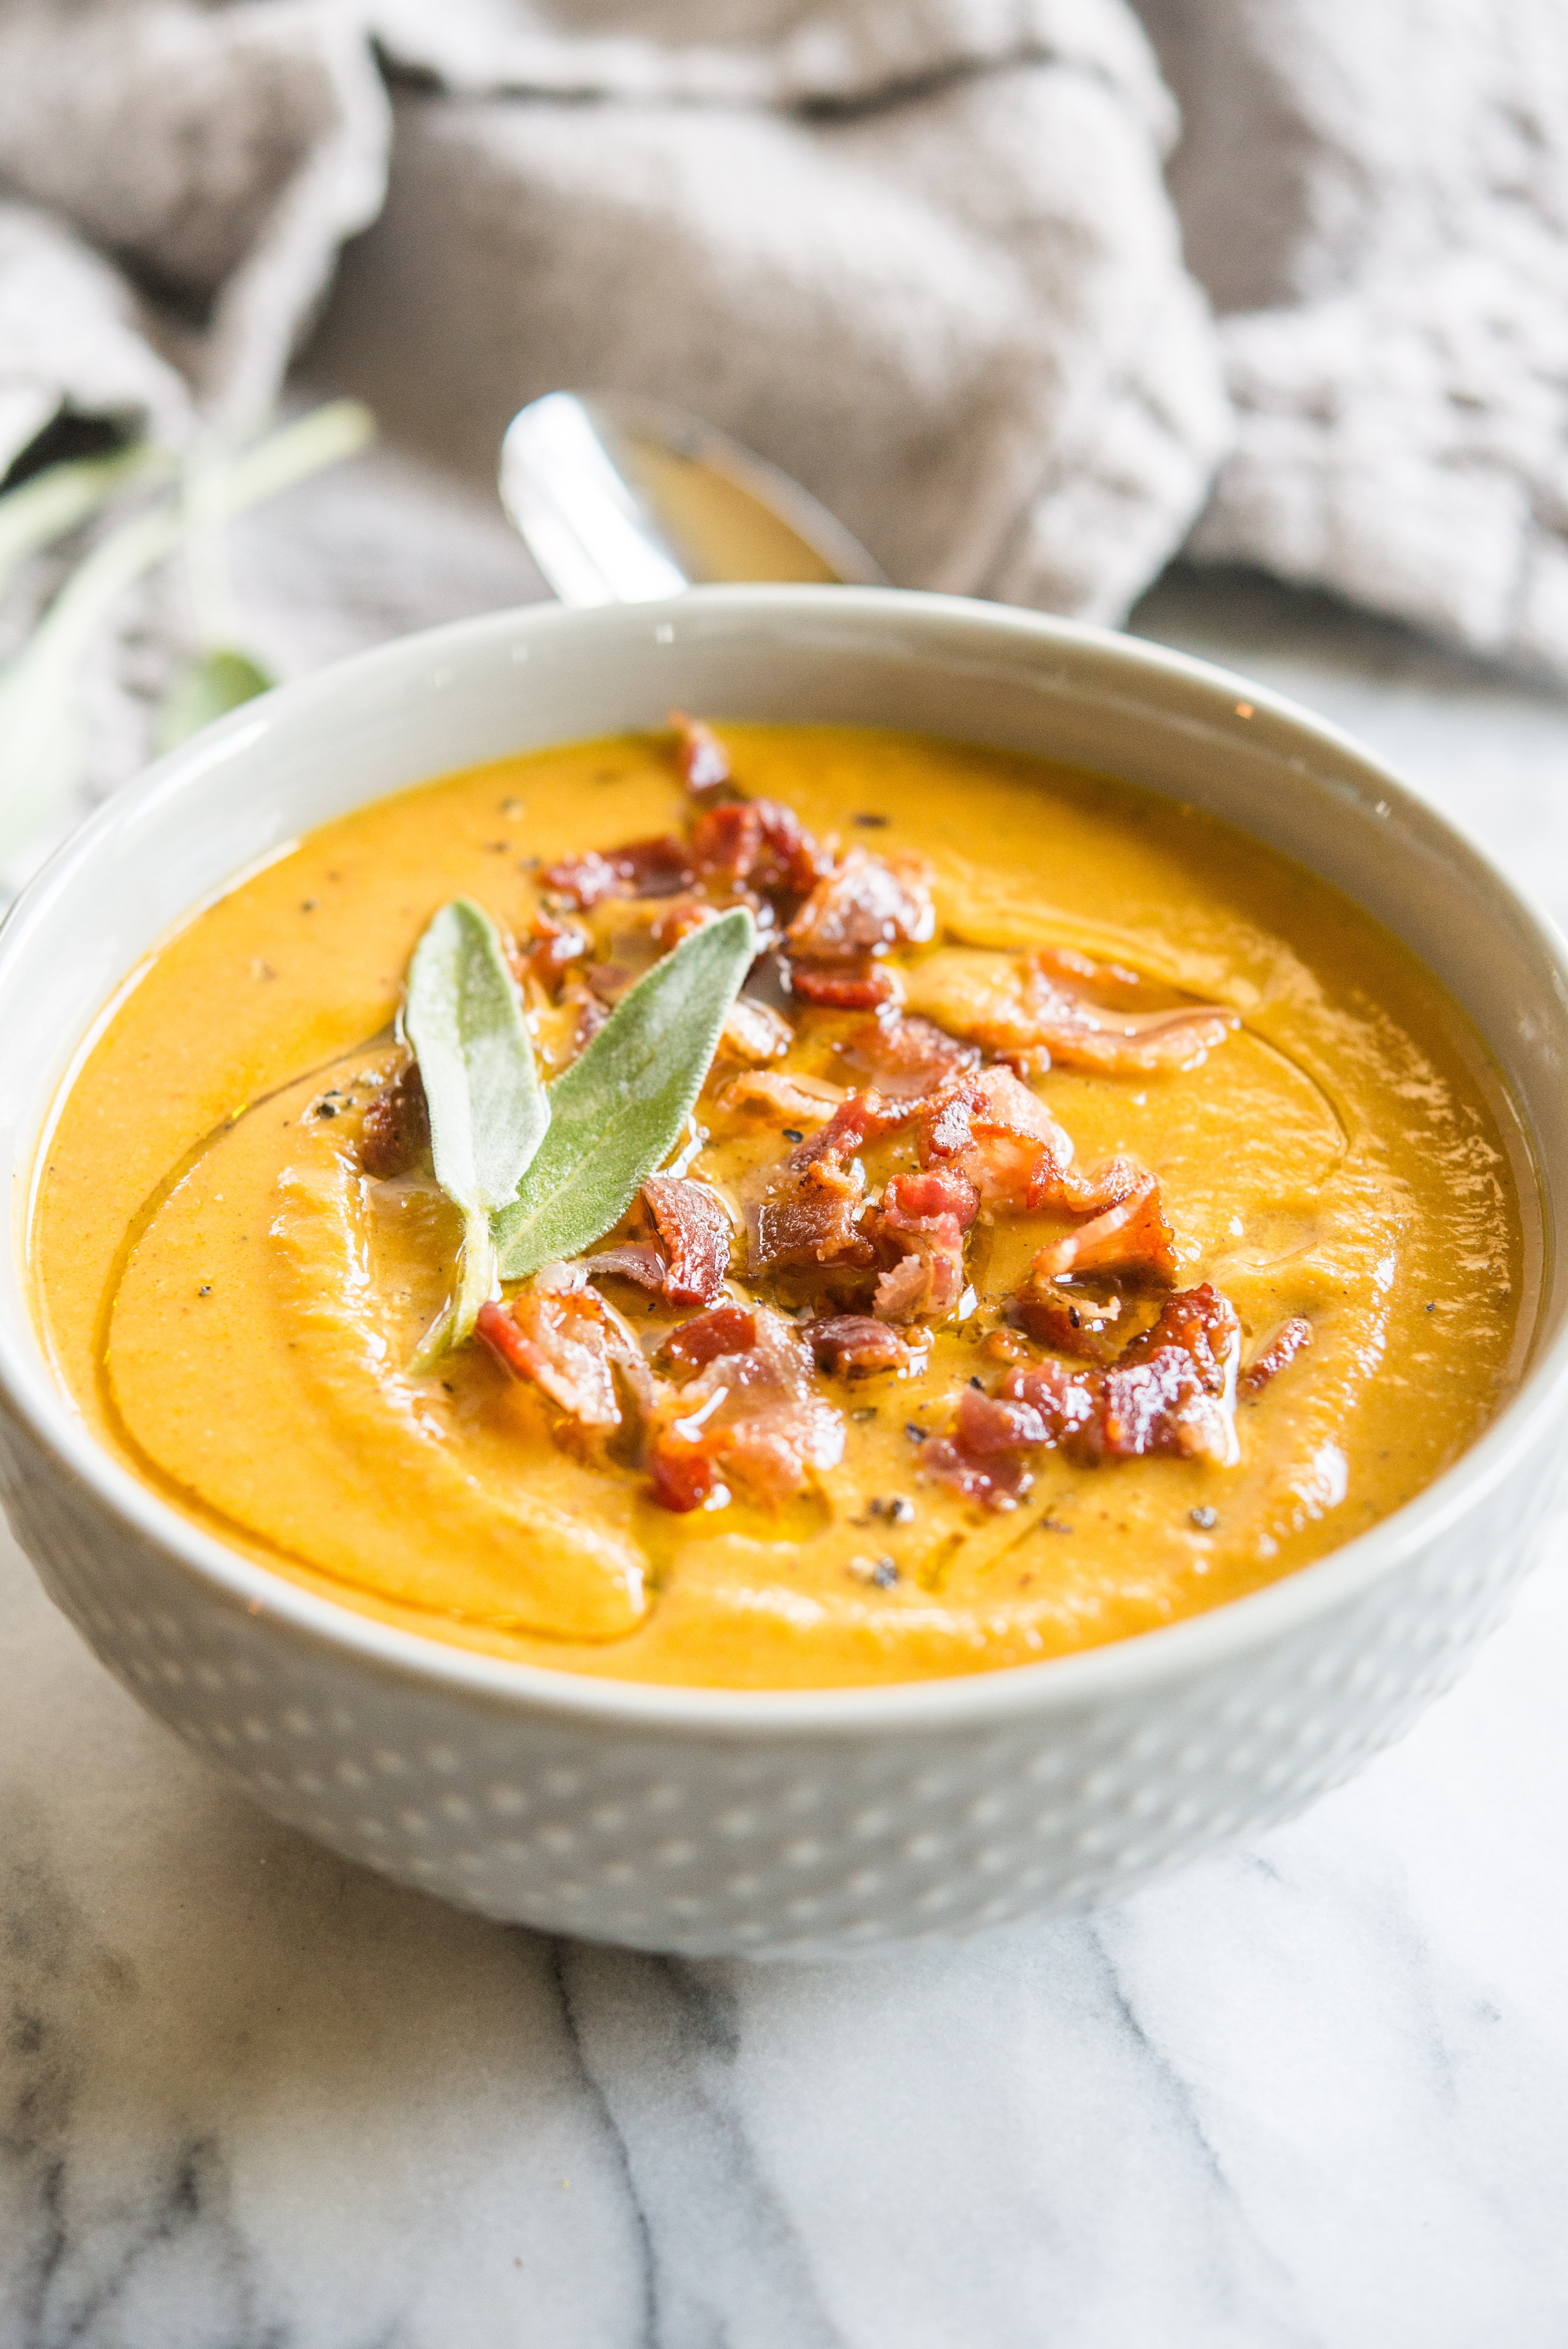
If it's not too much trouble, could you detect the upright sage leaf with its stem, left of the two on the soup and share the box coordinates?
[404,897,549,1372]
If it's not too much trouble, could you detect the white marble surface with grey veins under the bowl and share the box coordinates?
[0,458,1568,2349]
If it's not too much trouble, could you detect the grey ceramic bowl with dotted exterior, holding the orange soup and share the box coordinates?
[0,587,1568,1957]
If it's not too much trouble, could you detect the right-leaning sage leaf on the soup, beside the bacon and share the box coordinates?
[495,907,756,1280]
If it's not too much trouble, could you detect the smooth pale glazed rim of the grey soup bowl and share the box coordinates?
[0,585,1568,1743]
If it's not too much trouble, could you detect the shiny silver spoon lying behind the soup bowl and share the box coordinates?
[500,392,885,604]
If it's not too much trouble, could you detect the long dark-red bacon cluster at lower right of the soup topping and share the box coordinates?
[920,1283,1242,1508]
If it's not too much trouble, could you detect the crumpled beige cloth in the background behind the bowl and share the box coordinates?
[0,0,1568,714]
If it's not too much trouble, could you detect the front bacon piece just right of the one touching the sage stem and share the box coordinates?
[650,1306,843,1510]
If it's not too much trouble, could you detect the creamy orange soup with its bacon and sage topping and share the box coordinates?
[31,721,1530,1687]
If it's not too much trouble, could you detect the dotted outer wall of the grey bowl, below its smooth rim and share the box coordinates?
[0,1414,1563,1957]
